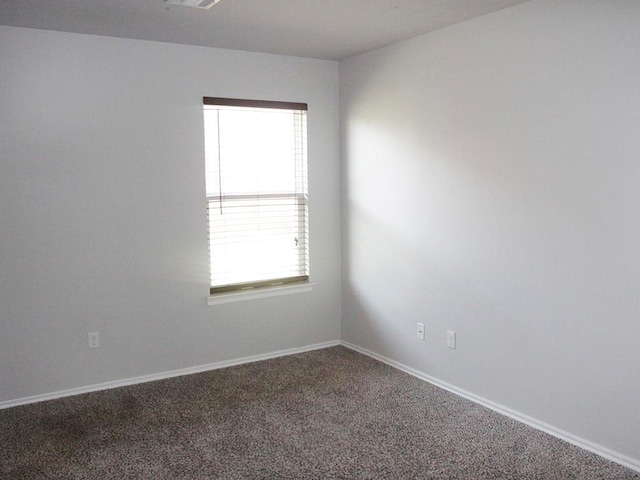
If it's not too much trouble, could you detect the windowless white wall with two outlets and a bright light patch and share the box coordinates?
[340,0,640,465]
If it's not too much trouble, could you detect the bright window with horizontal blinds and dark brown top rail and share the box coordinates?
[204,97,309,294]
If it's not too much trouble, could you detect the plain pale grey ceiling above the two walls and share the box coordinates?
[0,0,527,60]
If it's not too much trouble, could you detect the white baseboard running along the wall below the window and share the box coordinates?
[0,340,340,410]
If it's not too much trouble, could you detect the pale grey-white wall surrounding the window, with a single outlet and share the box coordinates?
[0,27,341,402]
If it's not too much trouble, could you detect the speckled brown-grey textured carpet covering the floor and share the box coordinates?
[0,347,640,480]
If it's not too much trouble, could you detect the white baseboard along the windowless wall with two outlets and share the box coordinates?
[340,340,640,472]
